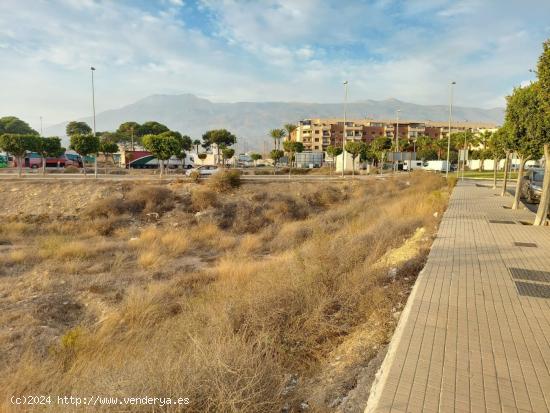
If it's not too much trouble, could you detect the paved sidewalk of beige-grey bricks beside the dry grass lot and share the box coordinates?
[366,181,550,413]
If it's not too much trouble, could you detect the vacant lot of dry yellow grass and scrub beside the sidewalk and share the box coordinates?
[0,174,448,412]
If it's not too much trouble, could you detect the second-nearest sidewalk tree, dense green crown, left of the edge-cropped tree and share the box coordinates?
[506,84,546,209]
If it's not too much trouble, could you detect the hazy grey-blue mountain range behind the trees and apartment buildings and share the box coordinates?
[46,94,504,151]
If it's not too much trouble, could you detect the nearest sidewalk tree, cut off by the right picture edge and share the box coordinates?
[534,39,550,225]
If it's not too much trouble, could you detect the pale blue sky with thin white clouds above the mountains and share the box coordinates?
[0,0,550,129]
